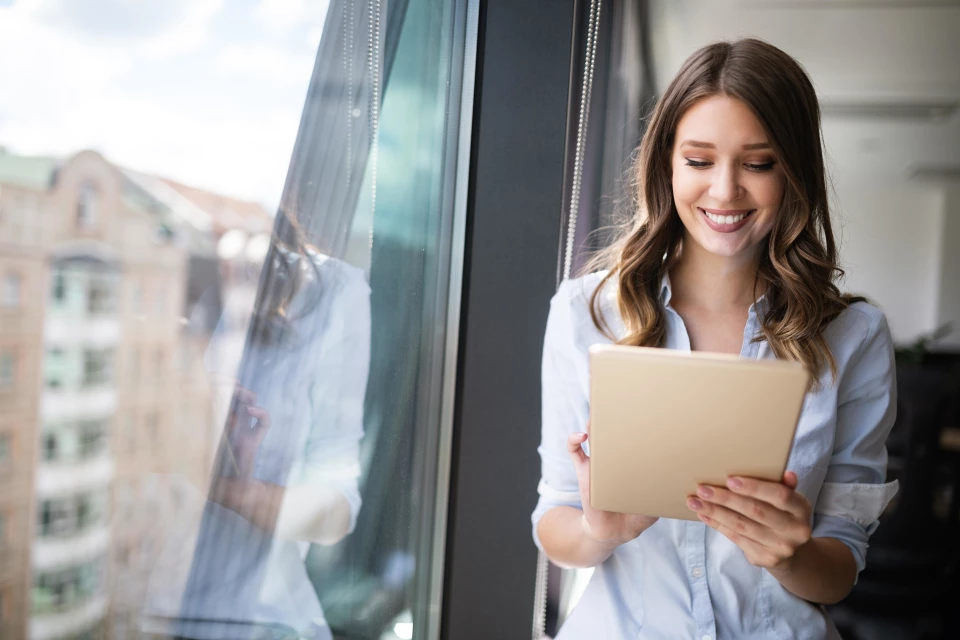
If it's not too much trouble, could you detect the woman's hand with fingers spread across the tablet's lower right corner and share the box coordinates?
[687,471,813,569]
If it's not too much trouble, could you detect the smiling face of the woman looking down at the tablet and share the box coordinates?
[671,95,784,258]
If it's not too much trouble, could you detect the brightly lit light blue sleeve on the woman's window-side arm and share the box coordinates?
[532,281,589,549]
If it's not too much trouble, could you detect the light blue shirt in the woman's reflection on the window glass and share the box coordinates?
[141,253,370,640]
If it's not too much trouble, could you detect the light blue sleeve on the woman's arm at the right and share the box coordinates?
[813,310,897,573]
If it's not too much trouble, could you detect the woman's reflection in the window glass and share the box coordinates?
[145,216,370,640]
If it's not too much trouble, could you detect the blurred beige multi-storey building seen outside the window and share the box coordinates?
[0,150,272,640]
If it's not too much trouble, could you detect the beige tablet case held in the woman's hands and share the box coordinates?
[589,345,808,520]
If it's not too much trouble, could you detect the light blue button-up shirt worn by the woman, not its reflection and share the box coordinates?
[533,274,897,640]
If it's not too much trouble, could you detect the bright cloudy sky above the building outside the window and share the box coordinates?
[0,0,328,210]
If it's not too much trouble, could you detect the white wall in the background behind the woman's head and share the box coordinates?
[649,0,960,348]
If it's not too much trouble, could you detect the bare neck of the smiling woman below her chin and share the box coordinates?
[670,236,763,311]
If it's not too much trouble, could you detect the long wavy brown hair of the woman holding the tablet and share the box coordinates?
[586,38,863,384]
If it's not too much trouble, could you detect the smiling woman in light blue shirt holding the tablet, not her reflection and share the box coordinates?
[533,39,896,640]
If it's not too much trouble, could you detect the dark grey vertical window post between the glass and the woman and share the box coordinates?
[440,0,577,640]
